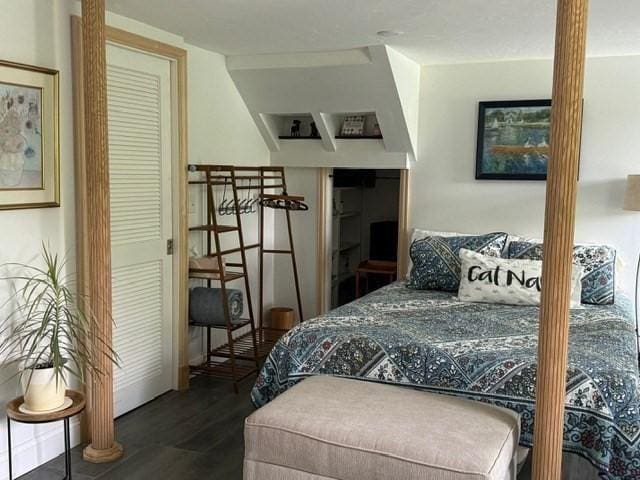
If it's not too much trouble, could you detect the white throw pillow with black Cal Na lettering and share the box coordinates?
[458,249,582,308]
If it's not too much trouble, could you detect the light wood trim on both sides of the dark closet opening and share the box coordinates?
[316,168,410,315]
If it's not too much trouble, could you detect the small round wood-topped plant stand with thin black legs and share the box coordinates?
[7,390,85,480]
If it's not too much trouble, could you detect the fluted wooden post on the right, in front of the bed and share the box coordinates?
[533,0,588,480]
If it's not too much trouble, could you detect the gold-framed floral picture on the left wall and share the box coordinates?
[0,60,60,210]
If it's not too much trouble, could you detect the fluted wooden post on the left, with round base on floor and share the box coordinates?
[82,0,122,463]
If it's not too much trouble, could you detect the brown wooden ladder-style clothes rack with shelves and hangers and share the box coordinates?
[189,164,304,393]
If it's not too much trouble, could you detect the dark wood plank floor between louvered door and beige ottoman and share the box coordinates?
[20,377,530,480]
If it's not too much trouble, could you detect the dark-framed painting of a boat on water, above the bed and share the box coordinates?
[476,100,551,180]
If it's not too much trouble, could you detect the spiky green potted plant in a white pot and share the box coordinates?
[0,244,117,412]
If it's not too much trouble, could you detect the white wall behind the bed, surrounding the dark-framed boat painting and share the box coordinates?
[416,57,640,290]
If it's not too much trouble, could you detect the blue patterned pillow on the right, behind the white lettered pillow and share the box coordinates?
[509,242,616,305]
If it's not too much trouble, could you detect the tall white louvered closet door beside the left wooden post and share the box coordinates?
[107,45,172,415]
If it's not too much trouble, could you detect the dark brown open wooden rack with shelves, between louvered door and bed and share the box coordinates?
[189,165,304,392]
